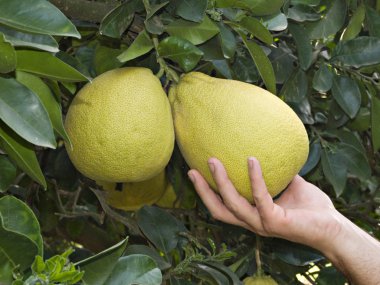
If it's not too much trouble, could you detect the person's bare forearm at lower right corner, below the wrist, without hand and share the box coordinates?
[321,212,380,285]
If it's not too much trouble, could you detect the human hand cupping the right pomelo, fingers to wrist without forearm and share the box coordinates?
[188,158,342,251]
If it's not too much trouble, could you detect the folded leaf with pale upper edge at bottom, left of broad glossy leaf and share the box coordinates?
[75,236,128,285]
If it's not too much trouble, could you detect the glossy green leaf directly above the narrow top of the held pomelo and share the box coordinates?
[158,37,203,72]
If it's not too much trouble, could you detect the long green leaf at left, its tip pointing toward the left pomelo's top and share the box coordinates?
[16,50,88,82]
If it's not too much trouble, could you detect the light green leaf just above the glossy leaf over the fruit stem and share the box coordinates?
[166,16,219,45]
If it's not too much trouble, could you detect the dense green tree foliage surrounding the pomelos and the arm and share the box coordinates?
[0,0,380,284]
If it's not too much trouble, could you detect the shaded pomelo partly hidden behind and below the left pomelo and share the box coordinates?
[97,170,169,211]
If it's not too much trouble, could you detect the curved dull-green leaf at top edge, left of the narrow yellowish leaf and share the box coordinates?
[308,0,347,39]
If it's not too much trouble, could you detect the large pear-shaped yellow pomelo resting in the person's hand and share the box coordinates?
[169,72,309,201]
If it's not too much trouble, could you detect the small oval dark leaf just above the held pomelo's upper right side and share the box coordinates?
[280,69,308,103]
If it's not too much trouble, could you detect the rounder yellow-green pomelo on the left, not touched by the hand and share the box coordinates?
[65,67,174,182]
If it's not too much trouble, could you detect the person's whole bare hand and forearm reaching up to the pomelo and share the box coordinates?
[188,157,380,285]
